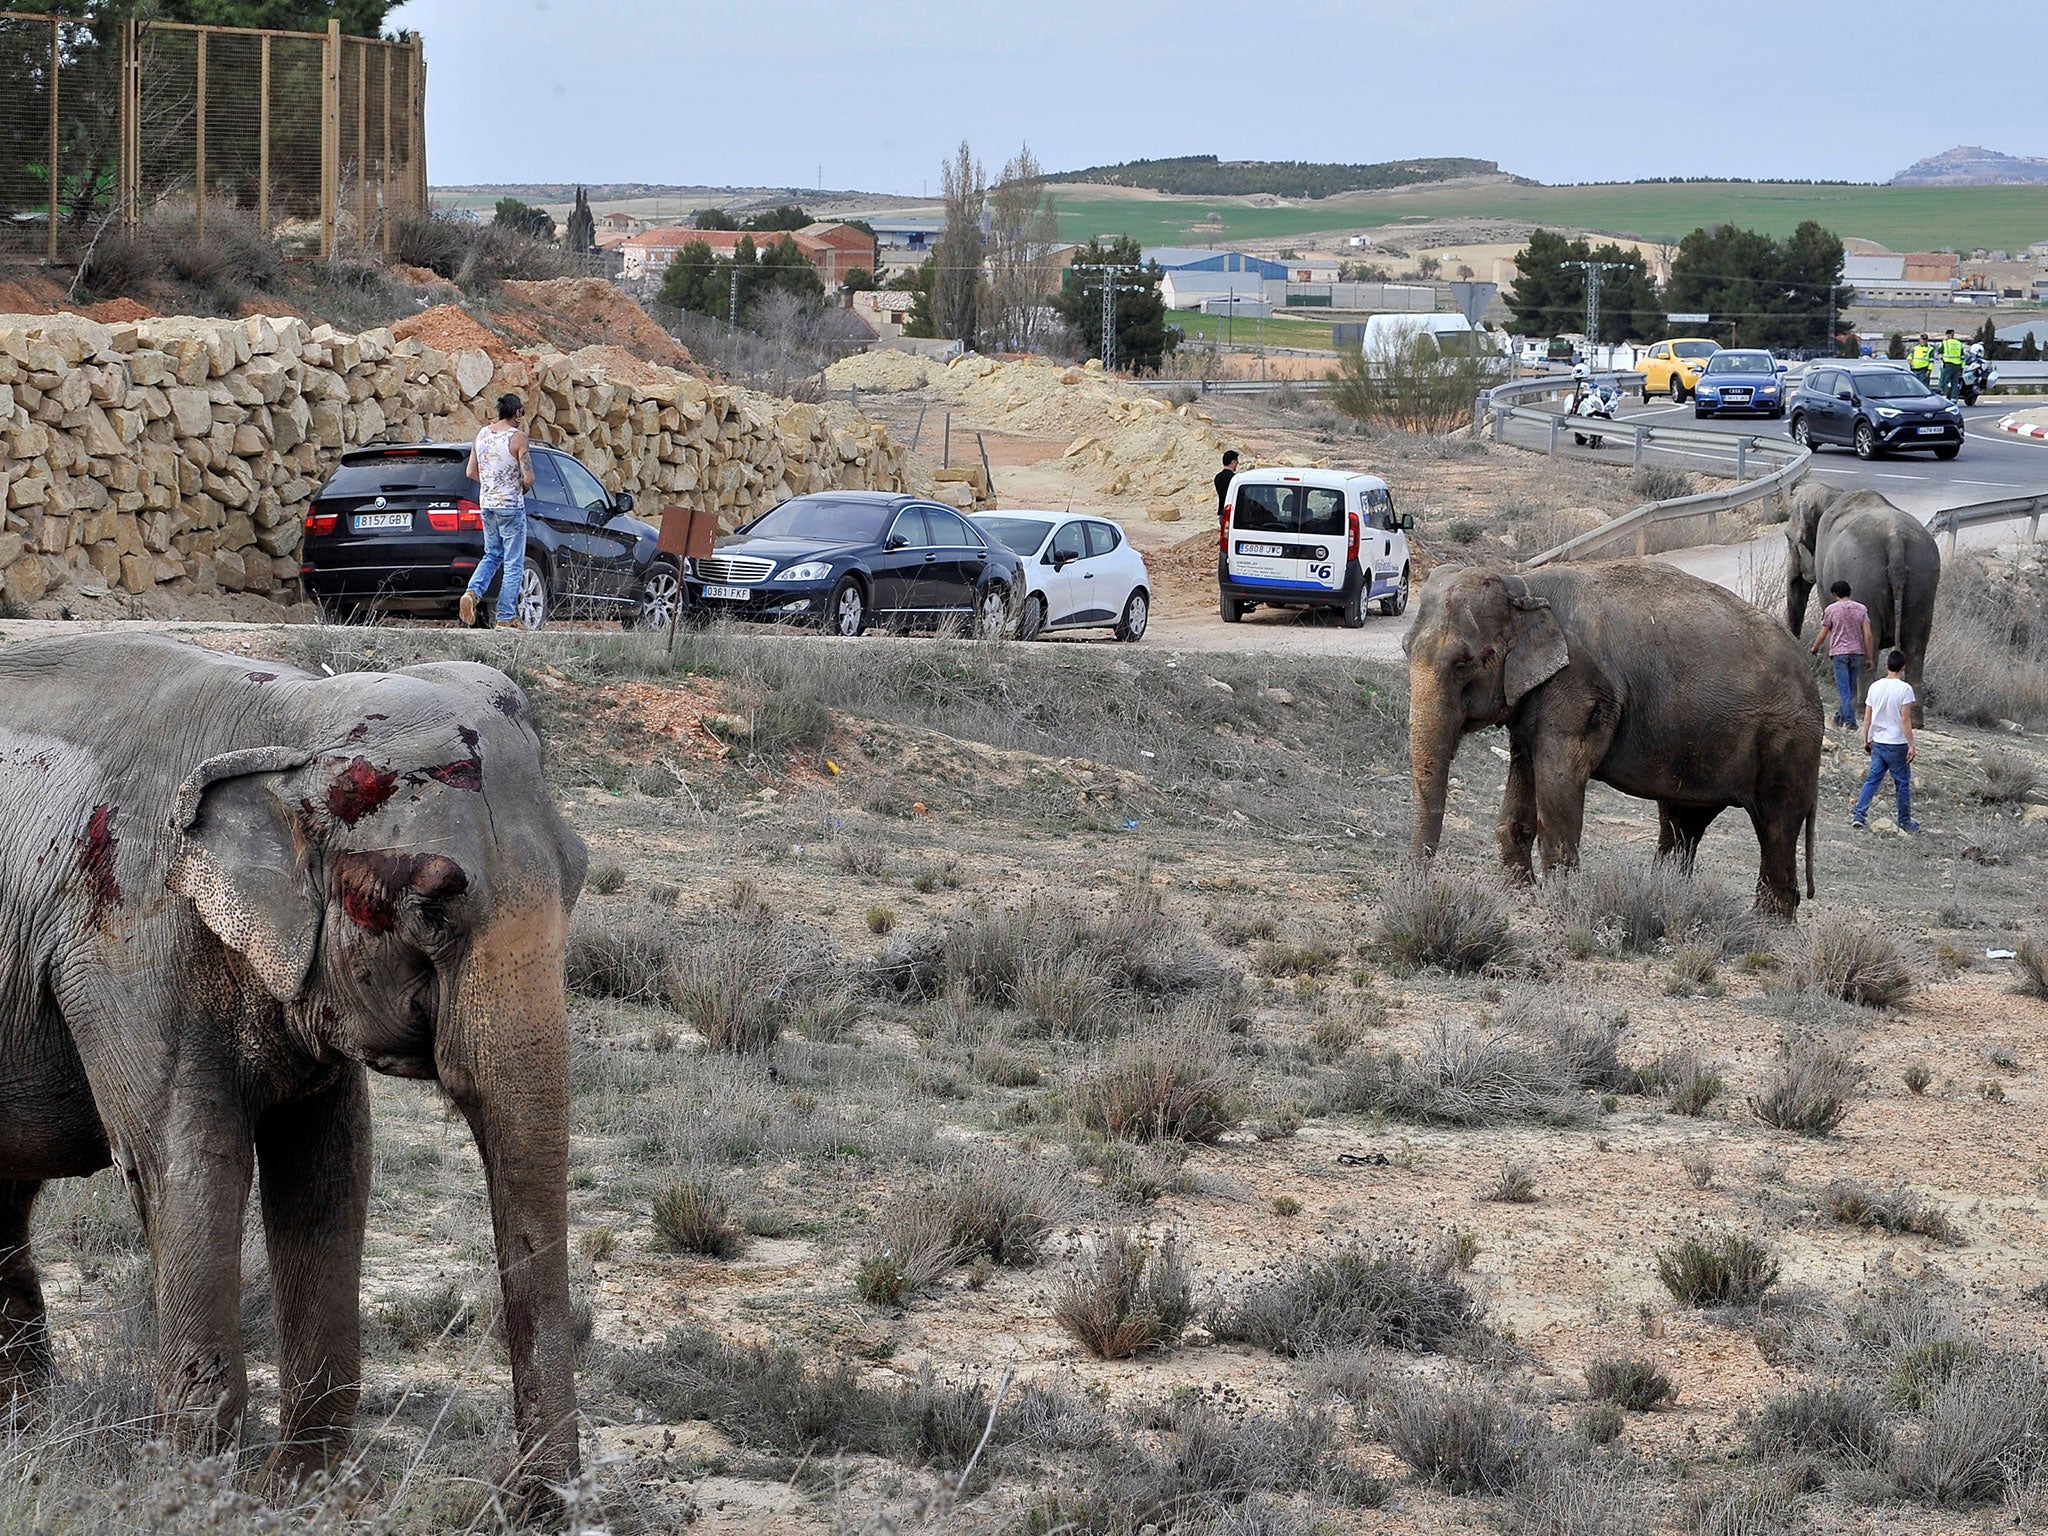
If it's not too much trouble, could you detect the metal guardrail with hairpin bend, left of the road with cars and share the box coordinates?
[1473,373,1812,567]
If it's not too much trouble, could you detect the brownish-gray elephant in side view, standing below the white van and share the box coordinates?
[1403,561,1821,920]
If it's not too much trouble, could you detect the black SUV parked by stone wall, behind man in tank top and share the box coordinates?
[299,442,682,629]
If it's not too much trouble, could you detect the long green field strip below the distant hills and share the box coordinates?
[1053,182,2048,252]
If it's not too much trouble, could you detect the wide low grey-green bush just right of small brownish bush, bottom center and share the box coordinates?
[1208,1243,1481,1356]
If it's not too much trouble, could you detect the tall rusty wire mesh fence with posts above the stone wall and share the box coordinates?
[0,12,426,262]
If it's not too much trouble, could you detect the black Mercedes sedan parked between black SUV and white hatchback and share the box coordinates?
[686,492,1022,639]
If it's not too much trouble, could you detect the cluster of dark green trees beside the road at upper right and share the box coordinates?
[1505,219,1855,350]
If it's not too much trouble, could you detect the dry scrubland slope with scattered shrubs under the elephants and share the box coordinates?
[0,578,2048,1536]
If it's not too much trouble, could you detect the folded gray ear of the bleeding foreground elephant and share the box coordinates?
[170,748,319,1004]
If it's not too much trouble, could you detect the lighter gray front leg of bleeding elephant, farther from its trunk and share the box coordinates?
[135,1053,254,1454]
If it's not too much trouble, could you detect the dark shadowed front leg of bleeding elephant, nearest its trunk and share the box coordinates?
[256,1067,371,1481]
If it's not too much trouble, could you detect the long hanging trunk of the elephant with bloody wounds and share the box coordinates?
[436,903,578,1491]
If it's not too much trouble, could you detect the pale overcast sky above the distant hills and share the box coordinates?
[389,0,2048,195]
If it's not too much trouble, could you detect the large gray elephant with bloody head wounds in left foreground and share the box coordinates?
[0,635,586,1487]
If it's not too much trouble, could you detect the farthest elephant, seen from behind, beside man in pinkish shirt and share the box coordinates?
[1786,487,1942,725]
